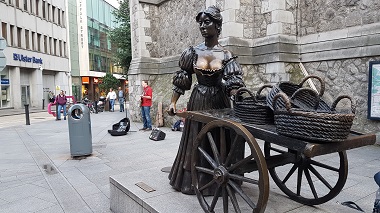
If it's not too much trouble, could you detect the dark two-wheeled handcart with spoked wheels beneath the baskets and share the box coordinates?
[177,109,376,213]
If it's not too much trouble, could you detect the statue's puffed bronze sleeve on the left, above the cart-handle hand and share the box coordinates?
[173,47,195,95]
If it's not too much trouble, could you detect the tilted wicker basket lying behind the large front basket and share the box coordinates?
[267,75,331,112]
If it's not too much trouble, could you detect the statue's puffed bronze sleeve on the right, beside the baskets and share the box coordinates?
[223,56,245,94]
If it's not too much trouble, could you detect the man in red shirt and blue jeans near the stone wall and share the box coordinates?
[140,80,153,131]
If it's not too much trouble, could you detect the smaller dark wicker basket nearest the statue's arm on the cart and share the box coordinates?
[233,85,273,125]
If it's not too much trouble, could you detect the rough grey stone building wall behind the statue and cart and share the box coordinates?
[129,0,380,139]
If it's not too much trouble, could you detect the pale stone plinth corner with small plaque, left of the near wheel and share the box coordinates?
[110,168,203,213]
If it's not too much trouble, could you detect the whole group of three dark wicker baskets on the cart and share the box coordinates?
[234,75,355,142]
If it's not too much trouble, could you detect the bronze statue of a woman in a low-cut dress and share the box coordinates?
[169,6,244,194]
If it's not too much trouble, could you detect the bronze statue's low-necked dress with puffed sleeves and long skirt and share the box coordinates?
[169,47,244,194]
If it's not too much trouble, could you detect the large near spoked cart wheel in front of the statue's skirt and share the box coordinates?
[191,120,269,213]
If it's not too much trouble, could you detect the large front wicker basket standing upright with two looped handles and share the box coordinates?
[273,93,355,142]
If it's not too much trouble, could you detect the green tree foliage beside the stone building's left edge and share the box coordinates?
[110,0,132,75]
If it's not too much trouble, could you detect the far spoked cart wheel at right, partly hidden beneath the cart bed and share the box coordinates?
[264,142,348,205]
